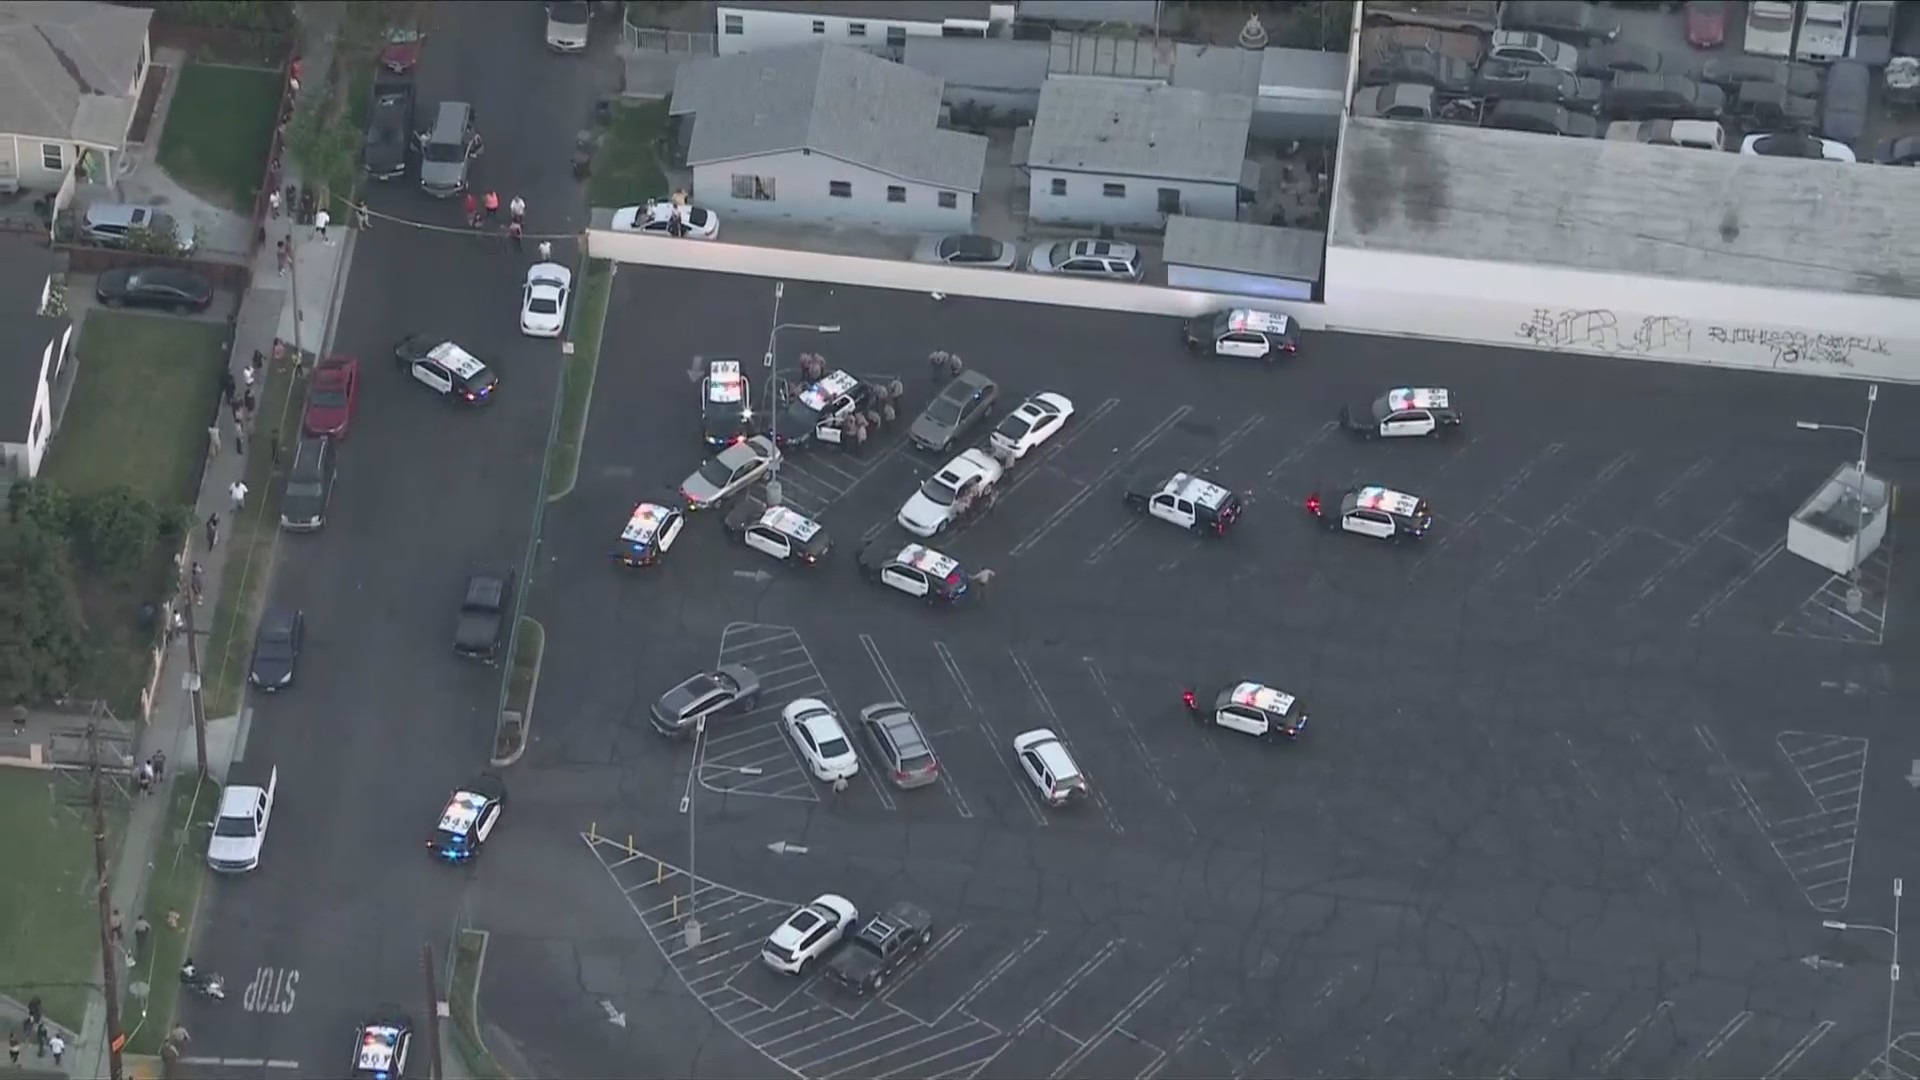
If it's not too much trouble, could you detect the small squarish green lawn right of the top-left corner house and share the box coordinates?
[159,63,280,211]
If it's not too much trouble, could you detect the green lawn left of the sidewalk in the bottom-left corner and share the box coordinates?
[0,769,132,1032]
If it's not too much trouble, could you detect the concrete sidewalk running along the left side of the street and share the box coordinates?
[67,6,353,1076]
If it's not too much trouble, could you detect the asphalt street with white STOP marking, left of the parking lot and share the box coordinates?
[182,4,591,1074]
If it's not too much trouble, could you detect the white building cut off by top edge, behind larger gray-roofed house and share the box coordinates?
[714,0,1014,58]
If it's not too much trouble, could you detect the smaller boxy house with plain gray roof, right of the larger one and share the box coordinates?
[1014,77,1254,229]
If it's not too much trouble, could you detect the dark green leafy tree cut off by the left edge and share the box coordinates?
[0,521,86,705]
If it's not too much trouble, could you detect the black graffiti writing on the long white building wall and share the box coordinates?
[1513,307,1887,367]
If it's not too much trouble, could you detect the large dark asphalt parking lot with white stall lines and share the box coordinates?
[478,267,1912,1076]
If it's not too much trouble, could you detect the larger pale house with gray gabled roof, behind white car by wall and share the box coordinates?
[672,42,987,233]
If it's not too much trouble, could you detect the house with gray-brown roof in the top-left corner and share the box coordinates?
[0,0,154,190]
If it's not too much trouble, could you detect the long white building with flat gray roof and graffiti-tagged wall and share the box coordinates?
[1325,117,1920,368]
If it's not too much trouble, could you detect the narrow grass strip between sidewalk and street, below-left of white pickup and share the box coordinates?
[121,769,215,1055]
